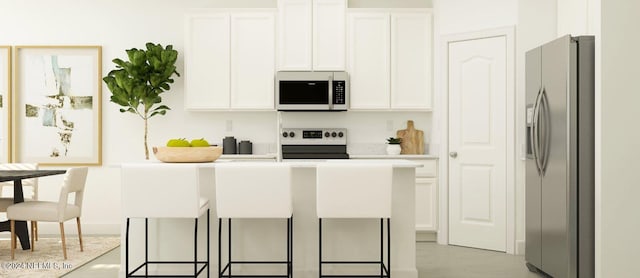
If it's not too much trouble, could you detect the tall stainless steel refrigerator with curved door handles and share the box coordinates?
[525,35,595,278]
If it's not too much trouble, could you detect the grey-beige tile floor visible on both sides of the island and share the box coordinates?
[64,242,544,278]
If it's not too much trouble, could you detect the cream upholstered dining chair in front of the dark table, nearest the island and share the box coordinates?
[7,167,88,260]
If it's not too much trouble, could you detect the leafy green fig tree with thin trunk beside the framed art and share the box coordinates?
[102,42,180,160]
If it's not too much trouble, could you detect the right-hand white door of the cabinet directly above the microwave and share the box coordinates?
[313,0,347,71]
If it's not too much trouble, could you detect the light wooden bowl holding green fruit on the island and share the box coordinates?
[153,147,222,163]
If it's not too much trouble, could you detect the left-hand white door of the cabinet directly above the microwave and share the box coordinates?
[278,0,312,70]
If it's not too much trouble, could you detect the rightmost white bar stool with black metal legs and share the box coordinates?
[316,162,393,277]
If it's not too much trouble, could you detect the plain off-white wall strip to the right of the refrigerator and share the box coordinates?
[596,0,640,278]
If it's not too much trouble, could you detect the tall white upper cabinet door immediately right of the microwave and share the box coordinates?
[348,13,390,109]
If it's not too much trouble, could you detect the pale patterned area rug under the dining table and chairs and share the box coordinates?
[0,236,120,278]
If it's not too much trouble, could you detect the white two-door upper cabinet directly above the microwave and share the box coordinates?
[278,0,347,71]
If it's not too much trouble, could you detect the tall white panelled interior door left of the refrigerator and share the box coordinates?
[448,36,507,251]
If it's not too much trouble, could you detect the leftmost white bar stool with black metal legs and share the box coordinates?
[122,164,209,277]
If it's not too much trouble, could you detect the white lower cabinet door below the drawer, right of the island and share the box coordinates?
[416,178,438,231]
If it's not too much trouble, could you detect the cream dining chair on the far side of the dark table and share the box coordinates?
[0,163,38,240]
